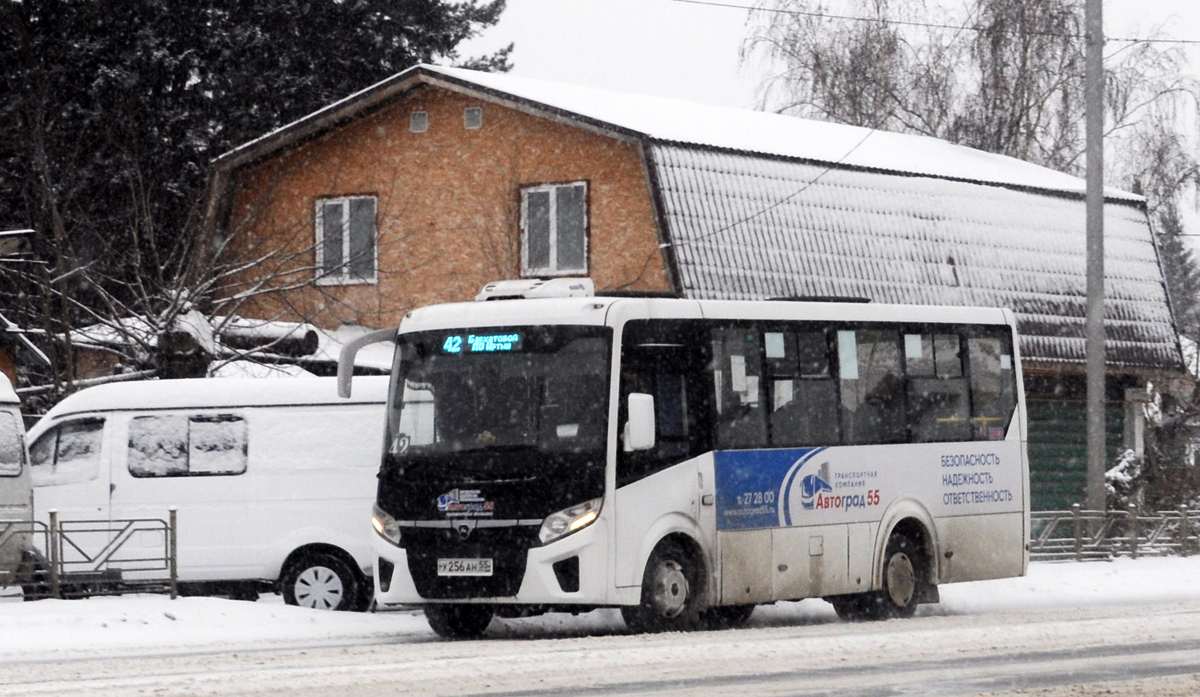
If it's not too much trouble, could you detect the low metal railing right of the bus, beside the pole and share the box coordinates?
[1030,504,1200,561]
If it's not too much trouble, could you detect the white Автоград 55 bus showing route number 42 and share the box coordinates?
[340,280,1028,637]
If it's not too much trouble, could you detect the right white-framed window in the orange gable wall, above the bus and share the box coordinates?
[521,181,588,276]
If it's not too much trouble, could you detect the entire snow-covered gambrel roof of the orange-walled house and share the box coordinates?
[216,66,1182,371]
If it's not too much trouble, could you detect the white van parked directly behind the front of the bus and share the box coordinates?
[29,378,388,609]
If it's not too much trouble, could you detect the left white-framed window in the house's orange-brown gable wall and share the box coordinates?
[317,196,376,284]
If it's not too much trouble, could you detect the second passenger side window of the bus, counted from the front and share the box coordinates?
[763,331,838,446]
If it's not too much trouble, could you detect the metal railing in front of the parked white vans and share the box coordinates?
[0,509,179,599]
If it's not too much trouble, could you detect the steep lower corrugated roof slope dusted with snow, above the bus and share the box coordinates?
[649,145,1182,371]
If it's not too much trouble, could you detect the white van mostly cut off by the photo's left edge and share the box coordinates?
[0,373,34,585]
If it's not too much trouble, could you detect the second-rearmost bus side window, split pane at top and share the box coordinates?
[904,334,971,443]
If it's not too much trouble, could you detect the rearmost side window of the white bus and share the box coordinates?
[967,337,1016,440]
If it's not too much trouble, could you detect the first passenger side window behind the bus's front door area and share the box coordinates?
[712,328,767,449]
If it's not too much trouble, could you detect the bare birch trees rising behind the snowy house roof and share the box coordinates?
[743,0,1200,195]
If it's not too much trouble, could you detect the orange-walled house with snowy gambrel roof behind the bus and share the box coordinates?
[206,66,1182,507]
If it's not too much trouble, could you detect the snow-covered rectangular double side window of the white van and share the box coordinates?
[128,414,246,477]
